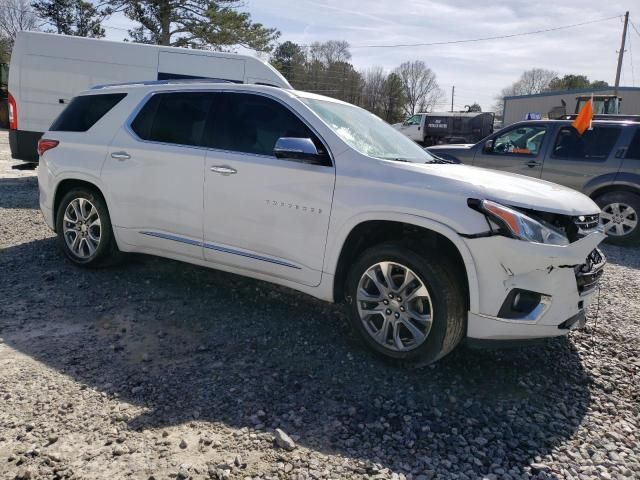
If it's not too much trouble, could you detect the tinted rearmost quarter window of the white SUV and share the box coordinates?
[49,93,127,132]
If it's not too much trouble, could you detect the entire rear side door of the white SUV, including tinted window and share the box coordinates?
[102,92,211,258]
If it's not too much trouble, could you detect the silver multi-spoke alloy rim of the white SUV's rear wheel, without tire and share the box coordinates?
[62,197,102,260]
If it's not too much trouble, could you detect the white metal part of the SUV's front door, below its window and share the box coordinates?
[204,150,334,285]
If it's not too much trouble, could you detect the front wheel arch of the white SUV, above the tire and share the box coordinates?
[327,213,479,311]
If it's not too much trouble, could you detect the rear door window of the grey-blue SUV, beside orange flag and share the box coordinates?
[553,127,620,160]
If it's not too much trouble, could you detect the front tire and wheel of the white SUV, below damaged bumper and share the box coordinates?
[347,242,466,366]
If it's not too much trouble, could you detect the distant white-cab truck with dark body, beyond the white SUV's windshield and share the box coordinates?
[394,112,494,145]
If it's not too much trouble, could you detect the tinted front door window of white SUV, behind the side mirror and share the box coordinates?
[203,93,326,159]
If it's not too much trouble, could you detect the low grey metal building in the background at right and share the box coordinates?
[503,87,640,126]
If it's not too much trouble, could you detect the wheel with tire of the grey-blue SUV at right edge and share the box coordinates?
[595,191,640,245]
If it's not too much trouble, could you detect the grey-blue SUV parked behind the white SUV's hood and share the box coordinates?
[429,120,640,245]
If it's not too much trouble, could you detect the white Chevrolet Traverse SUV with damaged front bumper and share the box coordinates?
[38,82,605,364]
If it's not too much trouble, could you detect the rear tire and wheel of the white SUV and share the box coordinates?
[56,187,117,267]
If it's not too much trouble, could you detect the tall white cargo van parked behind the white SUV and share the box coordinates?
[8,32,291,162]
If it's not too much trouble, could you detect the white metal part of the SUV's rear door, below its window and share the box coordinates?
[102,129,205,258]
